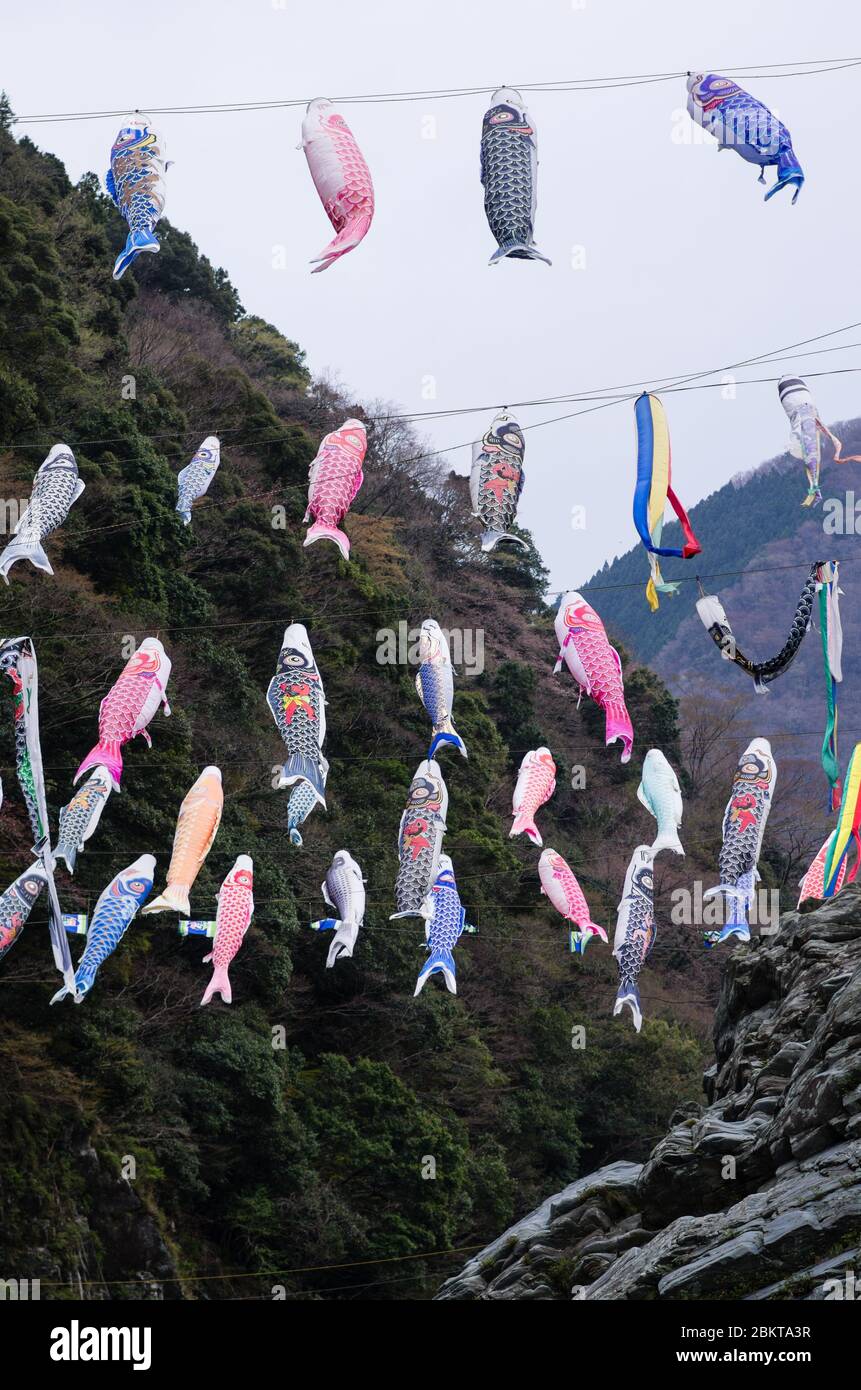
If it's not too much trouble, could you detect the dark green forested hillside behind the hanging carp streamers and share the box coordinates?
[0,108,823,1298]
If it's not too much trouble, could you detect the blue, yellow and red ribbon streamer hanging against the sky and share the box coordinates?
[634,391,701,613]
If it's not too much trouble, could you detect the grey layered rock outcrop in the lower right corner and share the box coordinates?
[437,887,861,1300]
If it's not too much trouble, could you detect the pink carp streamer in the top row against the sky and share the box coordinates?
[298,97,374,275]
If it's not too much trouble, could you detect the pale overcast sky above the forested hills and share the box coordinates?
[6,0,861,587]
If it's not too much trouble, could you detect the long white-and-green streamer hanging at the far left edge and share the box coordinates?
[0,637,75,986]
